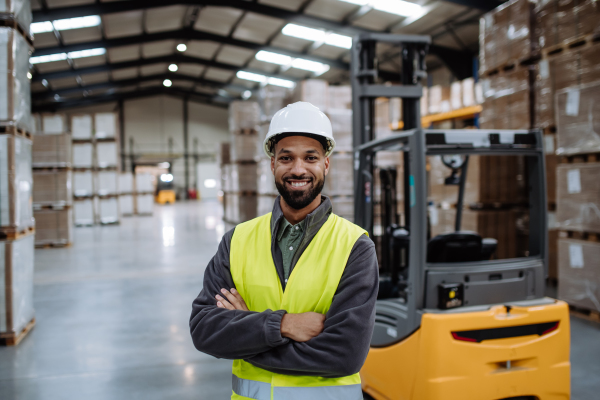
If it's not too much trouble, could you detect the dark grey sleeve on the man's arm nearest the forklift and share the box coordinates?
[245,236,379,378]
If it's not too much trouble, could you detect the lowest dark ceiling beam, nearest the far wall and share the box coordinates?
[32,87,227,113]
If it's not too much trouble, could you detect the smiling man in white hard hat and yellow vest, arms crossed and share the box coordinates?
[190,102,379,400]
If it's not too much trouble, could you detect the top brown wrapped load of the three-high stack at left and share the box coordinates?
[31,133,72,168]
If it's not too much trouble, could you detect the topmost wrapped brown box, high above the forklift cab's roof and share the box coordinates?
[479,0,539,75]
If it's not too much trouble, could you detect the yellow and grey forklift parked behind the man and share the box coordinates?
[351,34,570,400]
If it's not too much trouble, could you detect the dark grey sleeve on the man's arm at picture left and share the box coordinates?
[190,229,289,359]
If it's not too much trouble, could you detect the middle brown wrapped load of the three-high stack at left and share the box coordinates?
[33,169,73,206]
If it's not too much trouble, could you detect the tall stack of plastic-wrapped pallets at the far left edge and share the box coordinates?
[0,7,35,345]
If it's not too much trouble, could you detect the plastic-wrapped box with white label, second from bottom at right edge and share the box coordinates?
[556,163,600,232]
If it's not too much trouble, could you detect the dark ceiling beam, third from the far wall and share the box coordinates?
[31,53,298,82]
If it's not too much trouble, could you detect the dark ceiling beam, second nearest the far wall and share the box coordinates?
[32,72,249,100]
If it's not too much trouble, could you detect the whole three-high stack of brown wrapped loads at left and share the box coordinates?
[32,132,73,246]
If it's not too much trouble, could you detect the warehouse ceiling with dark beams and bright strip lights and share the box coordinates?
[31,0,502,111]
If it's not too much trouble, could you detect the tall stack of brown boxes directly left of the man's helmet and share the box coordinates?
[222,101,268,225]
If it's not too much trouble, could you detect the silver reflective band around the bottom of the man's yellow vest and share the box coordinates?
[232,375,363,400]
